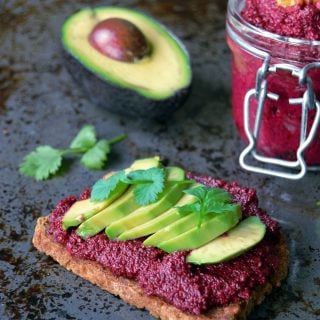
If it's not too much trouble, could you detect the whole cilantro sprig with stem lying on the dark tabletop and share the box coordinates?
[19,125,126,181]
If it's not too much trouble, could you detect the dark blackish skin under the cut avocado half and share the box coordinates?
[63,49,192,121]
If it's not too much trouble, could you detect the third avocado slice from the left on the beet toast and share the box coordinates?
[106,167,189,240]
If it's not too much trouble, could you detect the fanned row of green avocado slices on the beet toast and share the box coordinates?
[63,157,266,265]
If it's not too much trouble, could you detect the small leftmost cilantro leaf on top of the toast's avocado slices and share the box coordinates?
[91,171,125,201]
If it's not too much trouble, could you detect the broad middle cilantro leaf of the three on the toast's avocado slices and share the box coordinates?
[127,168,165,206]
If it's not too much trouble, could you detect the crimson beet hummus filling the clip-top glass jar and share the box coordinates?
[227,0,320,166]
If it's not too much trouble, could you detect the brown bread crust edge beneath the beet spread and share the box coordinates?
[32,216,288,320]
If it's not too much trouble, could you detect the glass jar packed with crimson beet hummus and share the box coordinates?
[227,0,320,175]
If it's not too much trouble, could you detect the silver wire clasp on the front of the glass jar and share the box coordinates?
[239,56,320,180]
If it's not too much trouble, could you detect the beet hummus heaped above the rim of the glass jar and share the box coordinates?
[242,0,320,40]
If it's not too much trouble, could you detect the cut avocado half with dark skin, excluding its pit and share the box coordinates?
[62,7,192,119]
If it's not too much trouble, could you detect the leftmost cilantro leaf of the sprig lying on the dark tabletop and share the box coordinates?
[19,146,62,181]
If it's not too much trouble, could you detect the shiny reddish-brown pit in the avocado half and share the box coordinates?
[89,18,149,63]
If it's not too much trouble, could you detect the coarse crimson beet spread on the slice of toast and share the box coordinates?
[48,173,280,314]
